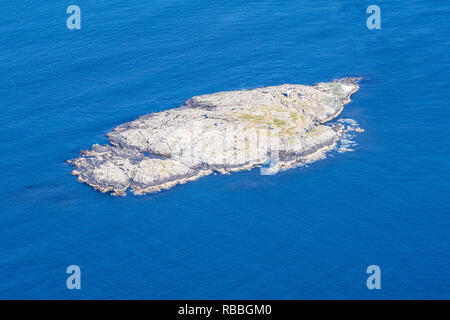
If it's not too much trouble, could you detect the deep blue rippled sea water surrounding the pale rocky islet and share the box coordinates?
[0,0,450,299]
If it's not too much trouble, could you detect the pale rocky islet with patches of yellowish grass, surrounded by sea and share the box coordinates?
[68,78,363,195]
